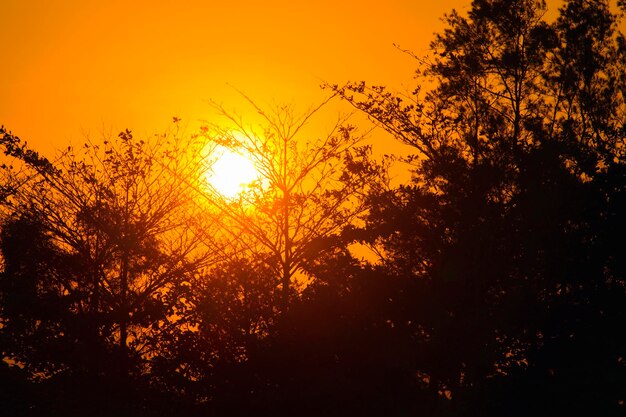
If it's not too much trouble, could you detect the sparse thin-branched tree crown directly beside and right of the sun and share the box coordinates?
[194,96,379,309]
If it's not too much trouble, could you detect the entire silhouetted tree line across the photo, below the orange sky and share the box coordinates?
[0,0,626,416]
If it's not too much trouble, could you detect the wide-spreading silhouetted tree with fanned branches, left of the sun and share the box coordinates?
[1,131,211,414]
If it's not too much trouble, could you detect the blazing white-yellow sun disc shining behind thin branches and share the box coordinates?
[207,147,259,198]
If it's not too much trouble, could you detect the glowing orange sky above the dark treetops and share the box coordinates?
[0,0,564,153]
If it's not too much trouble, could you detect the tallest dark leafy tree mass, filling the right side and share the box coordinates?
[326,0,625,415]
